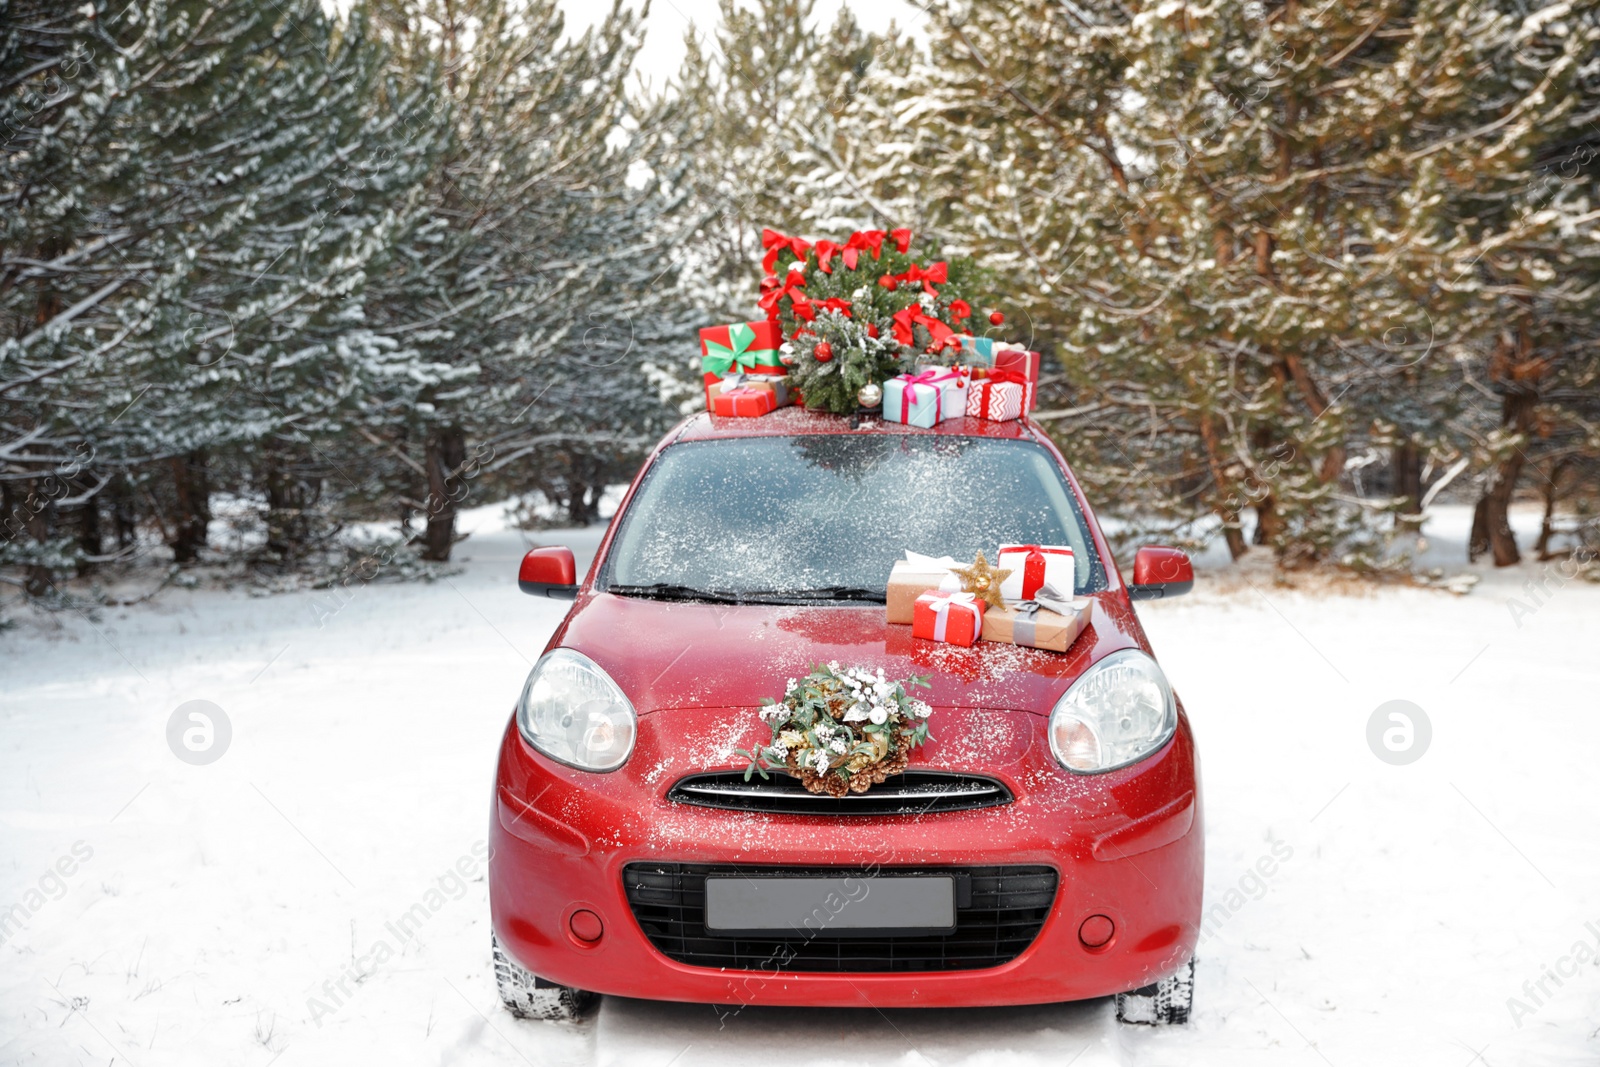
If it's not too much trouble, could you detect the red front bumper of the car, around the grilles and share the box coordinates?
[490,712,1203,1008]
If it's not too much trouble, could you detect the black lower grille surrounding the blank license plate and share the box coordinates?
[622,862,1056,974]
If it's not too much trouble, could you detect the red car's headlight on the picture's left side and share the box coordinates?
[517,648,638,771]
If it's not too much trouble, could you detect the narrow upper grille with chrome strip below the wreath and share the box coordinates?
[667,771,1013,816]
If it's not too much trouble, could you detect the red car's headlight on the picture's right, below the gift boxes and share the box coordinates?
[1050,648,1178,774]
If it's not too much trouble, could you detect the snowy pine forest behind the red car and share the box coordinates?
[0,0,1600,603]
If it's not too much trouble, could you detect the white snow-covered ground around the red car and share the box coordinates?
[0,509,1600,1067]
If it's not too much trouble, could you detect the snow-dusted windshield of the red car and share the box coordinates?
[600,434,1106,603]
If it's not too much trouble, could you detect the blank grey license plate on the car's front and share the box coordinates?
[706,875,955,937]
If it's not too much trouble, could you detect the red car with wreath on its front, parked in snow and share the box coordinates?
[490,408,1203,1022]
